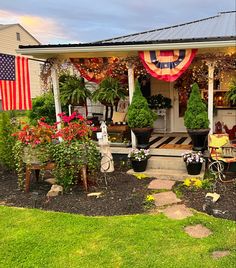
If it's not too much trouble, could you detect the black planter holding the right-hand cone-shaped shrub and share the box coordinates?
[188,128,210,152]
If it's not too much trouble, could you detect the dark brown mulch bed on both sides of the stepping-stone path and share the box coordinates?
[0,161,236,220]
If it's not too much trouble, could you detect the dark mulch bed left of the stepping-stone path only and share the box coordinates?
[0,160,151,216]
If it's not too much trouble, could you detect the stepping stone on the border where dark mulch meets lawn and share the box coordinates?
[163,204,193,220]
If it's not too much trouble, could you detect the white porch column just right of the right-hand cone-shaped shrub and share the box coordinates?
[207,61,215,134]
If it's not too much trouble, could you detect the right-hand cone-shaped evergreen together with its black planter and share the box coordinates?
[184,83,210,151]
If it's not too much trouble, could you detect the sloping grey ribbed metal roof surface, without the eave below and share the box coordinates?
[94,11,236,45]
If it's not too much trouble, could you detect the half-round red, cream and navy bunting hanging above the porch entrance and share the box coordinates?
[139,49,197,82]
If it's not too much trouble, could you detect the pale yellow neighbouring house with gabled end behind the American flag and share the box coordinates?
[0,24,42,108]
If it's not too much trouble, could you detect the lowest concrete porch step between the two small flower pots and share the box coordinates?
[127,168,204,181]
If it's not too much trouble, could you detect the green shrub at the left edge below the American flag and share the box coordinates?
[0,112,16,170]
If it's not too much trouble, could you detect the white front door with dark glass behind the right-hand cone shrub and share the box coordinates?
[173,89,188,132]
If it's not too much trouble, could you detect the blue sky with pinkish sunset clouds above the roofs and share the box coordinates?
[0,0,236,44]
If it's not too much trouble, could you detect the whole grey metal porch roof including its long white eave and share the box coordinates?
[18,11,236,56]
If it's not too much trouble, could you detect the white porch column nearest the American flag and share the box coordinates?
[51,65,61,129]
